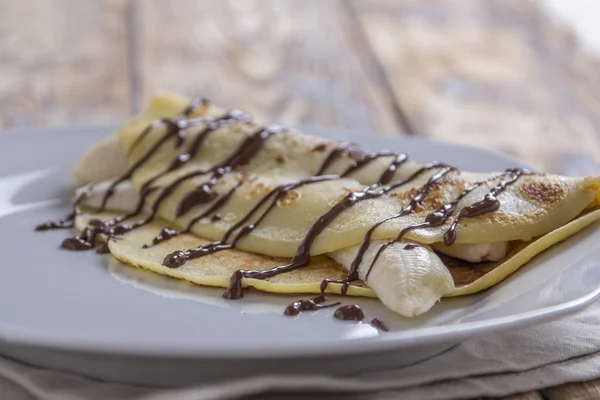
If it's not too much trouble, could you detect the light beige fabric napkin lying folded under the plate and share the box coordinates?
[0,302,600,400]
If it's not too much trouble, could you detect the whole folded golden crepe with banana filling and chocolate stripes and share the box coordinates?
[68,94,600,317]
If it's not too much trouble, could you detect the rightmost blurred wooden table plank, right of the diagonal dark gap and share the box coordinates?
[352,0,600,171]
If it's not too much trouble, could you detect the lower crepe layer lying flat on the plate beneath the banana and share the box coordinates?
[75,210,600,297]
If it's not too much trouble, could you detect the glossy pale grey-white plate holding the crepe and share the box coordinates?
[0,127,600,385]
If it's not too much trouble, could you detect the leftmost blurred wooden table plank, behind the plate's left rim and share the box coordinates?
[0,0,130,127]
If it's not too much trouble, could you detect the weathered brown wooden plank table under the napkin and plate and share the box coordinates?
[0,0,600,399]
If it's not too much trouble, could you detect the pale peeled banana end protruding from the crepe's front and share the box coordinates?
[328,240,454,317]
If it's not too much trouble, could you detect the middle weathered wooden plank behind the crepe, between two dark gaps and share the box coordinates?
[135,0,402,132]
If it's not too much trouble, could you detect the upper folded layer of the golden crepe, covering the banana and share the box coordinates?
[113,95,600,257]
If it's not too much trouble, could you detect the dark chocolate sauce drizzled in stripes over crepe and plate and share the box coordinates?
[36,98,530,331]
